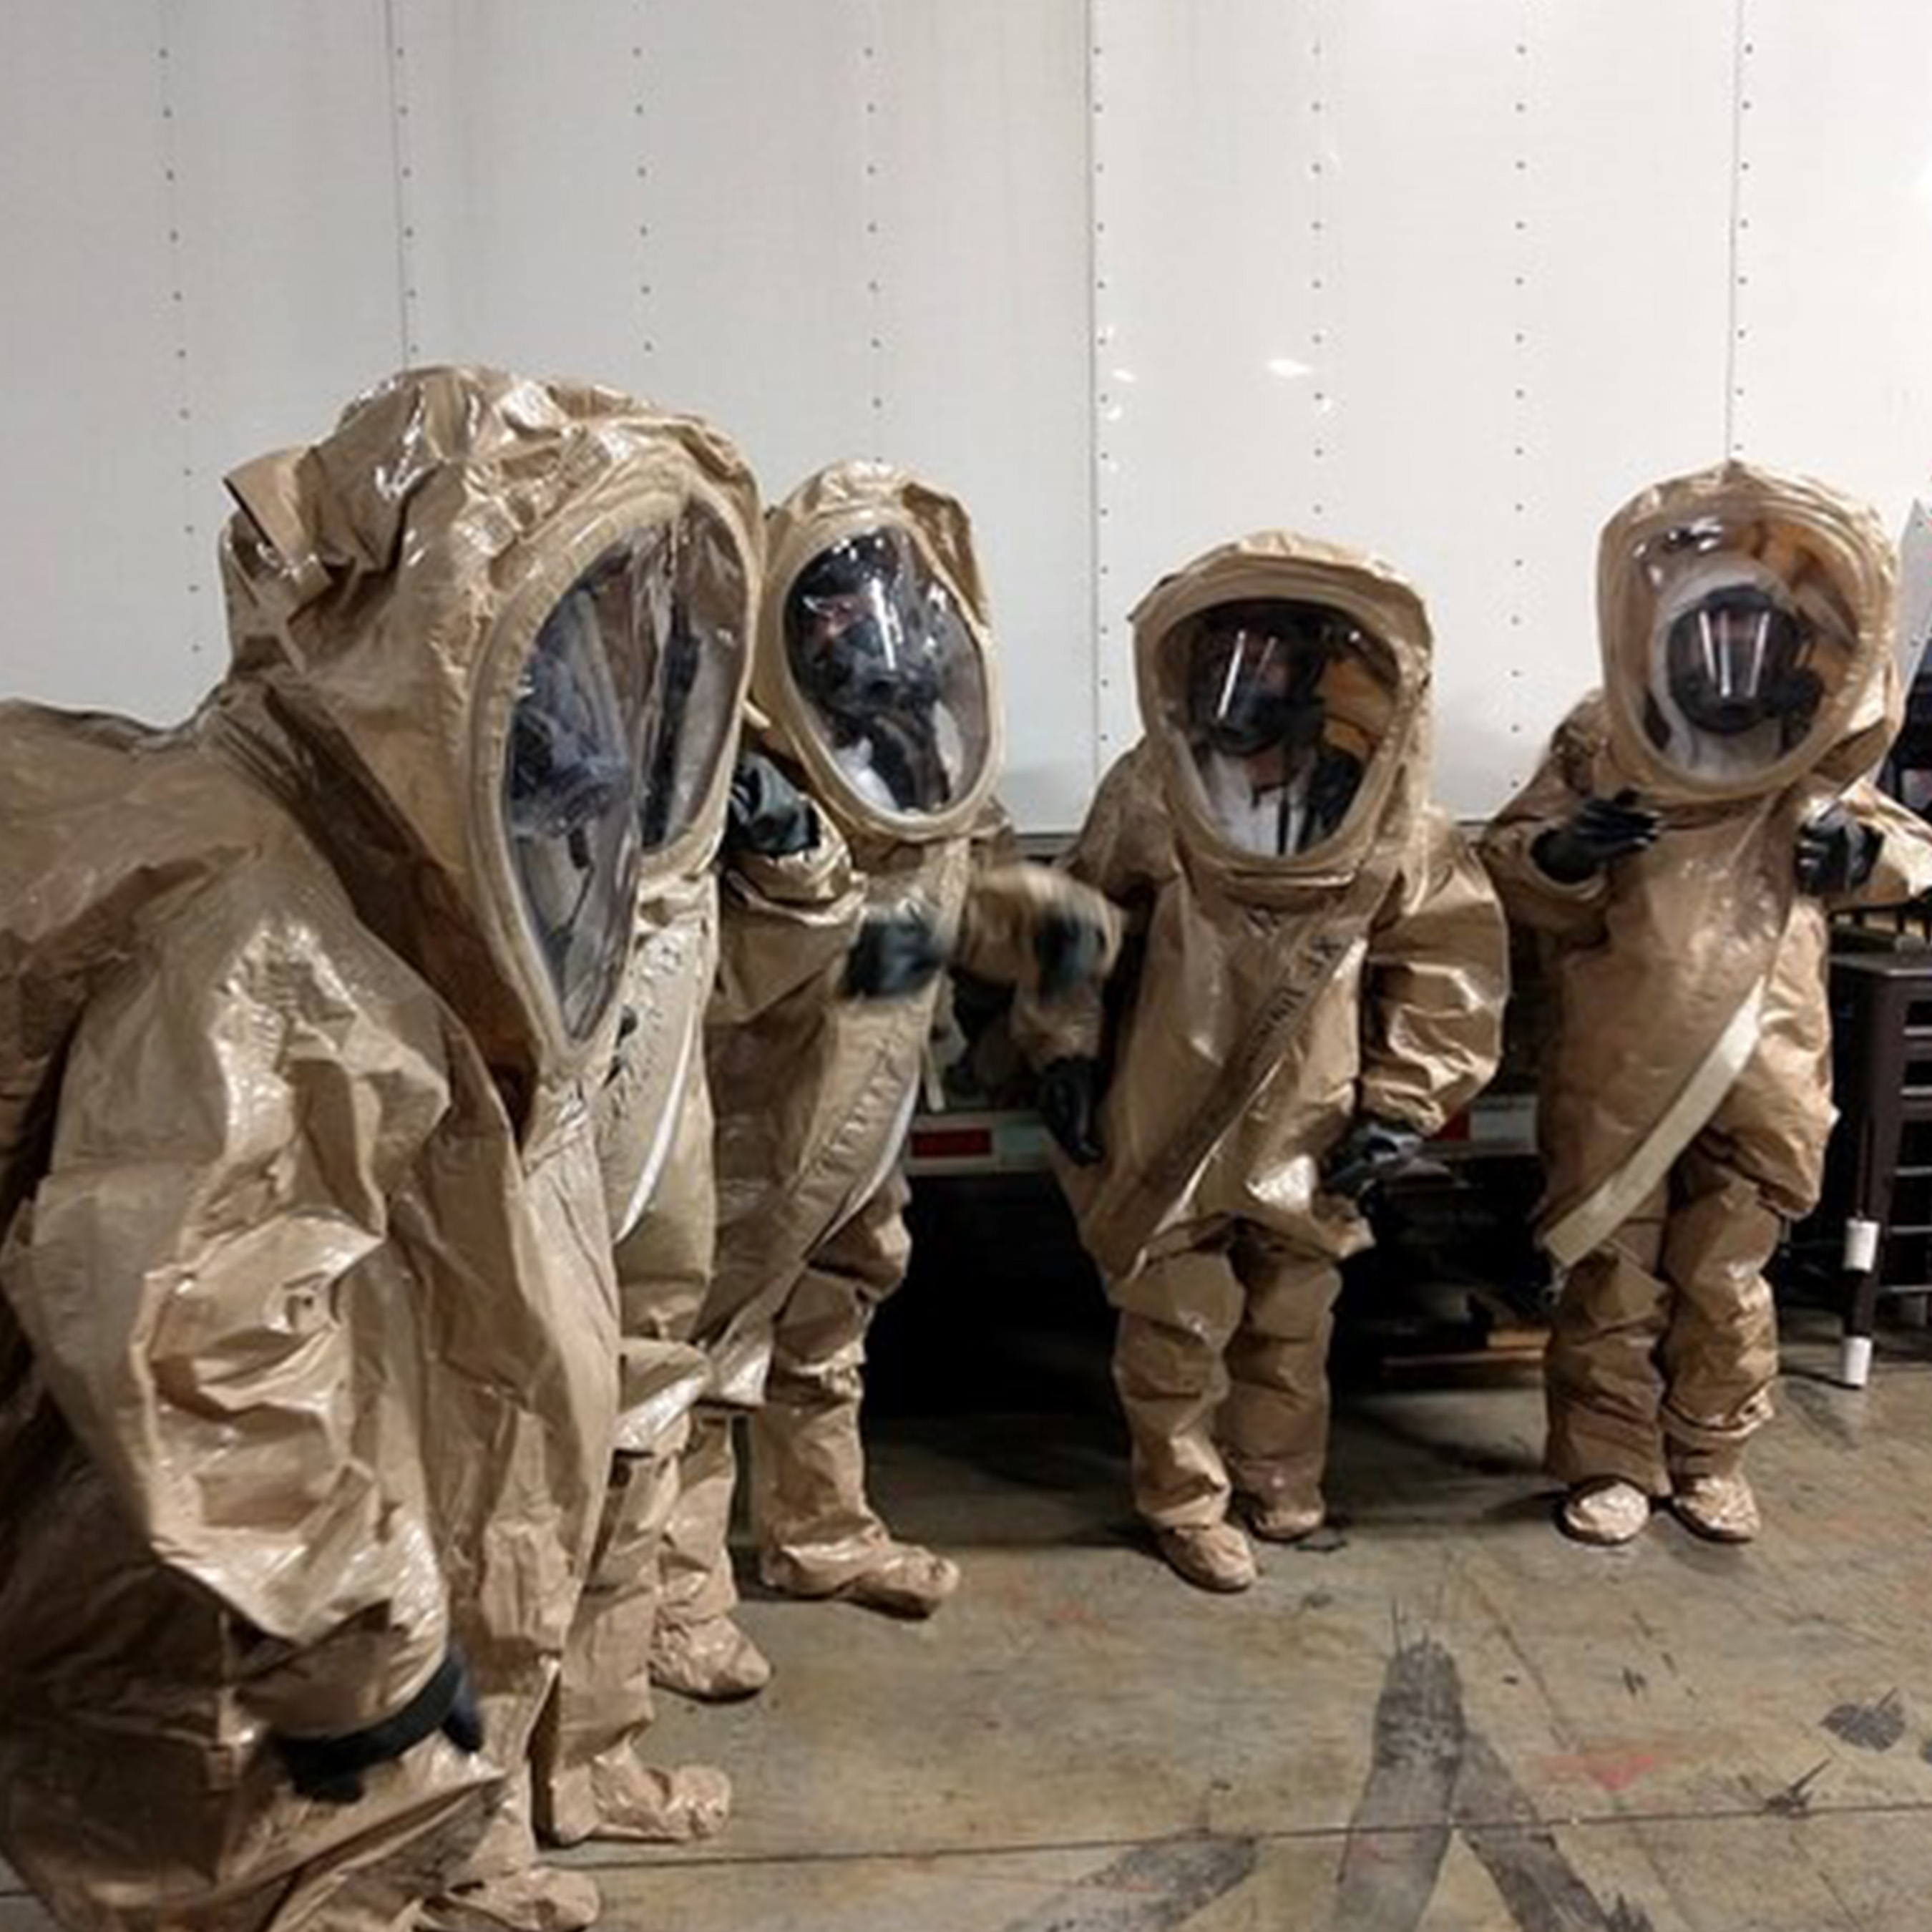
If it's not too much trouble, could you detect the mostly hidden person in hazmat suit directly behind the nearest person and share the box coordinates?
[535,469,763,1845]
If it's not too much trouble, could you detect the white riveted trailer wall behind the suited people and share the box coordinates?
[0,0,1932,829]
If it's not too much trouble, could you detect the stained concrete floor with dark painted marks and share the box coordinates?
[0,1324,1932,1932]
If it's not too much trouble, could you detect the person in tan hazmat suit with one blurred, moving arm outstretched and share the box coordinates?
[653,462,1117,1698]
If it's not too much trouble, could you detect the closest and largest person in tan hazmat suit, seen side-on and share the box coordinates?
[0,369,751,1932]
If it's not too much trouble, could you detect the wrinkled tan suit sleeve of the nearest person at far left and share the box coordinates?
[6,877,450,1733]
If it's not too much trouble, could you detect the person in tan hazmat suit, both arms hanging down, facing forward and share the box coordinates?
[1015,532,1507,1590]
